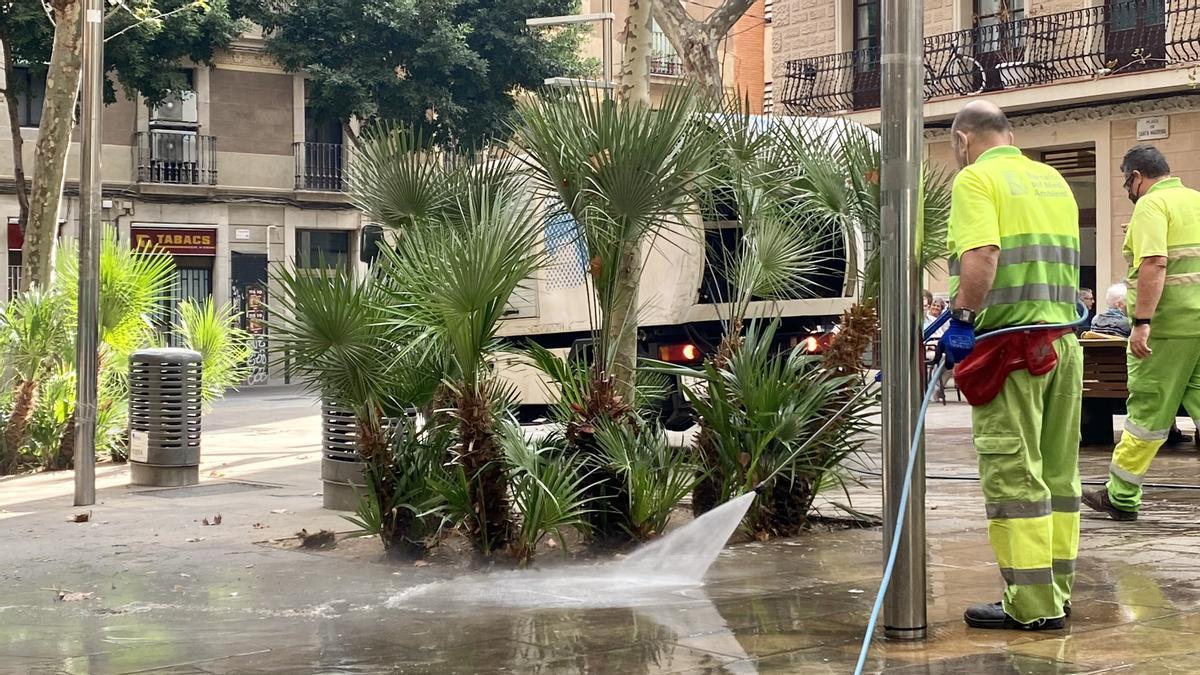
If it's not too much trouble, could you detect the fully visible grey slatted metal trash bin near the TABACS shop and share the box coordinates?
[130,348,203,488]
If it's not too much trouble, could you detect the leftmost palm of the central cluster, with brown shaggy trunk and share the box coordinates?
[270,264,444,555]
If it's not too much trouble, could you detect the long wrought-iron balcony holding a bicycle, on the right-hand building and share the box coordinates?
[782,0,1200,114]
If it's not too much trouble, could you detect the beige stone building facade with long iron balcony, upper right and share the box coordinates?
[772,0,1200,291]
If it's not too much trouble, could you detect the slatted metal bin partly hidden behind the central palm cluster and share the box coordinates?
[320,399,366,510]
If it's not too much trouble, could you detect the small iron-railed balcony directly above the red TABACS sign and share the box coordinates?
[137,130,217,185]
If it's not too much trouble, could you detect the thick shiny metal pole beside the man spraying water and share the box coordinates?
[880,0,926,640]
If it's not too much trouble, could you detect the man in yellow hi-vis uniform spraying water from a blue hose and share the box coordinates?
[942,101,1084,631]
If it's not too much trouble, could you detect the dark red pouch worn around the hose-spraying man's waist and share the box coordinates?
[954,328,1070,406]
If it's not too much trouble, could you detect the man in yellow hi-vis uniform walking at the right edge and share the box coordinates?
[1084,145,1200,520]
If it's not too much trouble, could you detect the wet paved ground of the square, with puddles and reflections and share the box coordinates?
[0,390,1200,675]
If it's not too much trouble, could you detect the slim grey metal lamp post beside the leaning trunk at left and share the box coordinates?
[74,0,104,506]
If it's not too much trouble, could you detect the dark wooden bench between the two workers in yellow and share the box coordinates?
[1079,339,1188,446]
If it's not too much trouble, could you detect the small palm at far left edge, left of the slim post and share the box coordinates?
[0,288,71,476]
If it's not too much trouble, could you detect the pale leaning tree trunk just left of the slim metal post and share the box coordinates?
[20,0,82,291]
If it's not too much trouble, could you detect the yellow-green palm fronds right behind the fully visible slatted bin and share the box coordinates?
[175,298,251,406]
